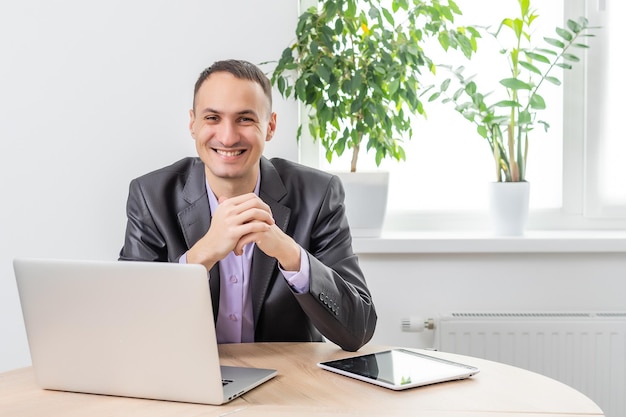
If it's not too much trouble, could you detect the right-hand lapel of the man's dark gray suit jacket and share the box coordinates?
[250,158,291,325]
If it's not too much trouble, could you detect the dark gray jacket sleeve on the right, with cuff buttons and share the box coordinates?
[296,177,377,351]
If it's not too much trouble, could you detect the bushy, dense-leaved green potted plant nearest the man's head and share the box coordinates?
[264,0,478,234]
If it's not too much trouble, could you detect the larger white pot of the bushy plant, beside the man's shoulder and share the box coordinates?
[334,171,389,237]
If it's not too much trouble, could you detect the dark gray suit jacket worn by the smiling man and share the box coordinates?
[120,158,377,351]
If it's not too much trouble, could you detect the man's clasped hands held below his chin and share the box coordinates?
[187,193,300,271]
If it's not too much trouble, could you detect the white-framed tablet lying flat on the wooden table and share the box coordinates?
[318,349,479,390]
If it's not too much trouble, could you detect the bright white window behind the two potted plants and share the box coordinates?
[302,0,626,230]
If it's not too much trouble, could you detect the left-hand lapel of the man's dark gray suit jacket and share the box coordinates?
[178,159,220,320]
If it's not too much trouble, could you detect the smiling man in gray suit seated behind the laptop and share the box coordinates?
[120,60,377,351]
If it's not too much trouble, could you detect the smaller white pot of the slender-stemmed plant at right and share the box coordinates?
[489,181,530,236]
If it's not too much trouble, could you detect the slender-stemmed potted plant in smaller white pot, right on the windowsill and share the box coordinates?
[422,0,593,235]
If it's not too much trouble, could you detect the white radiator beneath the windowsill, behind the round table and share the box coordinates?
[435,312,626,417]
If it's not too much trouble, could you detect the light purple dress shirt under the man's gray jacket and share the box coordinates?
[180,169,309,343]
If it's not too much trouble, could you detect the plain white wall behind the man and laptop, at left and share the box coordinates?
[0,0,298,371]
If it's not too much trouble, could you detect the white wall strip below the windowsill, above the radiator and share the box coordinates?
[359,248,626,347]
